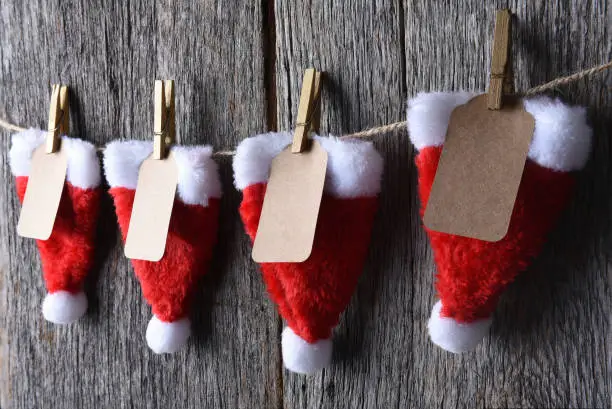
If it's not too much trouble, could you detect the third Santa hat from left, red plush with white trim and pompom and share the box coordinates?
[233,132,383,373]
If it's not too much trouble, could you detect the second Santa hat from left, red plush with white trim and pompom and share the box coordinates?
[104,141,221,353]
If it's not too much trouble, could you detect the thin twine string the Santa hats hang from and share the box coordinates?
[0,61,612,157]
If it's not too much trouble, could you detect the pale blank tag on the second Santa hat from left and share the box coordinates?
[125,152,178,261]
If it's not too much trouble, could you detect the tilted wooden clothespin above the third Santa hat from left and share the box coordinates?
[291,68,321,153]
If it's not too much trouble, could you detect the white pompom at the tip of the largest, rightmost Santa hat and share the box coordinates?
[428,301,493,354]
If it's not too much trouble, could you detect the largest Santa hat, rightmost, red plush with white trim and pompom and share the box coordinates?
[408,93,591,353]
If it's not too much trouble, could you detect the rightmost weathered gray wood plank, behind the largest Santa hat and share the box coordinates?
[401,1,612,408]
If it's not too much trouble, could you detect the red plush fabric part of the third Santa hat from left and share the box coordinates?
[240,183,378,343]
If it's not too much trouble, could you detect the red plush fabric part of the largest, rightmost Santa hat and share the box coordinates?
[416,147,574,322]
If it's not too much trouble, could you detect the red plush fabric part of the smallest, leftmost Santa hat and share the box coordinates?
[15,176,101,293]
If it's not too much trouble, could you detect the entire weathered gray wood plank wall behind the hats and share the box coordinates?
[0,0,612,408]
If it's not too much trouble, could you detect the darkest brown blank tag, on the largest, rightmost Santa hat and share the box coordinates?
[423,95,535,241]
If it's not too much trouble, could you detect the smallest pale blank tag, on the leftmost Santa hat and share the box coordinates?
[17,144,68,240]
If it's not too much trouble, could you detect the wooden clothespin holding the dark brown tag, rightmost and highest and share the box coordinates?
[487,9,514,110]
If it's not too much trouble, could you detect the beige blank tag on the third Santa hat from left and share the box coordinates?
[253,141,327,263]
